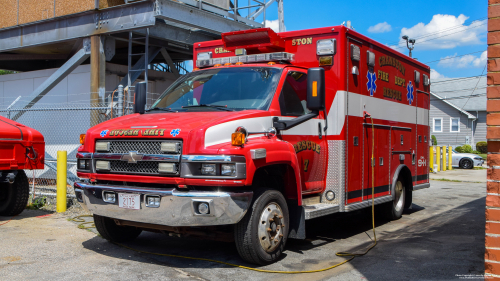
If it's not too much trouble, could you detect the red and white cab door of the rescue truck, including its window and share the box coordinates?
[279,68,328,194]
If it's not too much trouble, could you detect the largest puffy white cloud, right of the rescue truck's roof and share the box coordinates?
[399,14,486,49]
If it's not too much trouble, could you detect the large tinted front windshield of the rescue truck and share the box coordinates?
[151,67,282,111]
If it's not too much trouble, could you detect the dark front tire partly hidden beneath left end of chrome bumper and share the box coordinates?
[94,215,142,243]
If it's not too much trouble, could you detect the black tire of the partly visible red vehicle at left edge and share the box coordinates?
[0,170,30,216]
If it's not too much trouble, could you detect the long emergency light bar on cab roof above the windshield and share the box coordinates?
[196,52,295,68]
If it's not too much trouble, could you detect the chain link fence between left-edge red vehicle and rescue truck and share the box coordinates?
[0,92,159,201]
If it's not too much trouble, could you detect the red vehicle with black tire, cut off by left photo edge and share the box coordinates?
[0,116,45,216]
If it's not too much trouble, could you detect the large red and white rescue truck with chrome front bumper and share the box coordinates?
[75,26,430,264]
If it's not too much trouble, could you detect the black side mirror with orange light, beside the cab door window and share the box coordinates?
[307,67,325,112]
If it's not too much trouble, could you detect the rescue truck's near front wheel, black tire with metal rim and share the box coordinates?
[234,190,289,265]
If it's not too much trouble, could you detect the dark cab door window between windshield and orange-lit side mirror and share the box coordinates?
[279,71,310,116]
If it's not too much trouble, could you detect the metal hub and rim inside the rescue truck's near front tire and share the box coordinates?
[257,203,285,252]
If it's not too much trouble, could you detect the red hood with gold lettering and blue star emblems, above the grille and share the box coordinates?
[85,110,270,153]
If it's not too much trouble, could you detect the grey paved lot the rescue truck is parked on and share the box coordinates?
[0,178,486,280]
